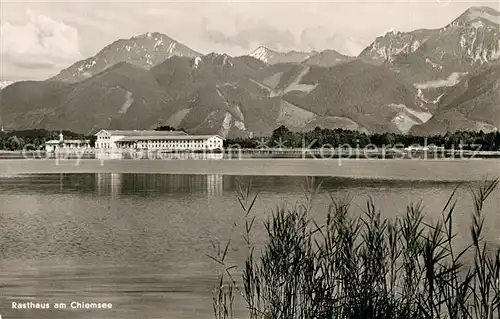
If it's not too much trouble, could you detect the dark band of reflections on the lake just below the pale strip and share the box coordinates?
[0,173,464,197]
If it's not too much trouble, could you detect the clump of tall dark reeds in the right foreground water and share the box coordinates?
[211,179,500,319]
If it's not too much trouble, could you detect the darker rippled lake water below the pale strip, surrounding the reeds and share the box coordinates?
[0,173,500,319]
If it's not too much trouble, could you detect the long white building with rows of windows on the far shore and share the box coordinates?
[95,130,224,151]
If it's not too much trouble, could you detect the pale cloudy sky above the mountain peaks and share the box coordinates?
[0,0,499,80]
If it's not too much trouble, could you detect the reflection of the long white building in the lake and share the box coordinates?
[95,173,224,197]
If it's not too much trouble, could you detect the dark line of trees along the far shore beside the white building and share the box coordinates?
[0,126,500,152]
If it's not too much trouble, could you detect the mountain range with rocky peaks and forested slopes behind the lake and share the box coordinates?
[0,7,500,137]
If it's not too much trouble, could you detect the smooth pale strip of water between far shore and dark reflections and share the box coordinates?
[0,158,500,182]
